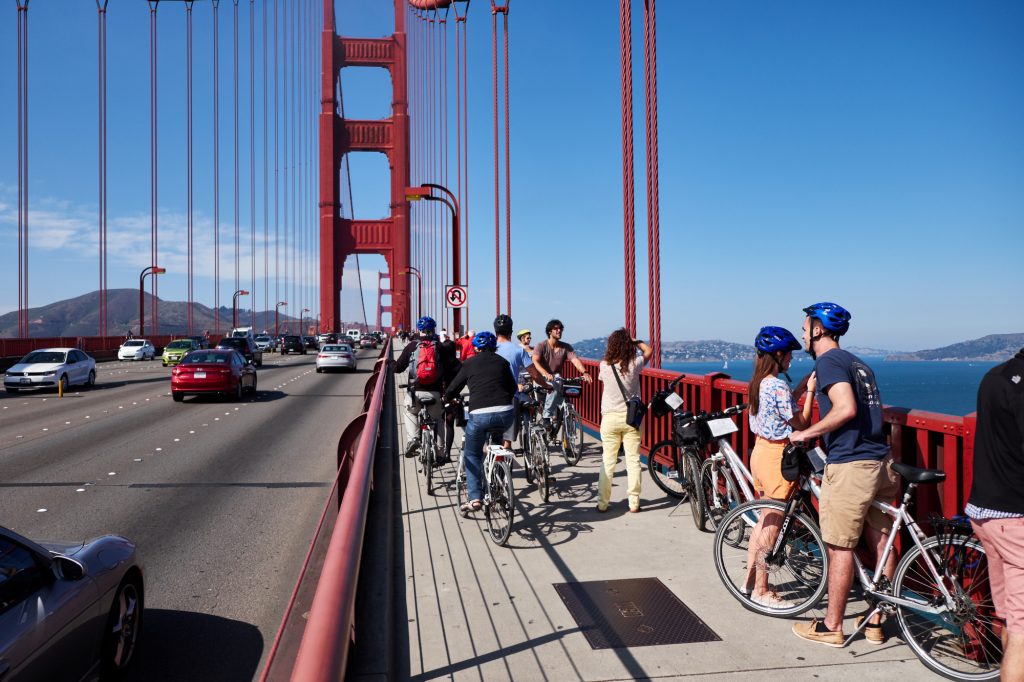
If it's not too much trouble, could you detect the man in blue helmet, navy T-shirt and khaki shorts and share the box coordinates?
[790,302,899,646]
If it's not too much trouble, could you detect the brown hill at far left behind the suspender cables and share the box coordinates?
[0,289,344,338]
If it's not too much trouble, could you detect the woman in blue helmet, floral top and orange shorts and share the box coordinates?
[746,327,814,608]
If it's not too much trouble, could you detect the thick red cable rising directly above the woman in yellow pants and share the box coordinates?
[618,0,637,336]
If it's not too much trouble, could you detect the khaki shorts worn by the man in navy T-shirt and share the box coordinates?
[818,456,900,549]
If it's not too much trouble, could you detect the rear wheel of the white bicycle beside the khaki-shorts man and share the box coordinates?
[893,537,1002,680]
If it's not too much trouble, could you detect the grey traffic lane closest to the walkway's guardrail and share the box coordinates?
[3,350,380,680]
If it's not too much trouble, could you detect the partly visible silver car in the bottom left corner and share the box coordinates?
[0,526,144,682]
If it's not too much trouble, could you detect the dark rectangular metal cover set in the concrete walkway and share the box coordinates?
[554,578,721,649]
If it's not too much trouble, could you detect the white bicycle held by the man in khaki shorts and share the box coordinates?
[715,449,1001,680]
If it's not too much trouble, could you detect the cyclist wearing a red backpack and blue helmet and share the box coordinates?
[395,316,457,457]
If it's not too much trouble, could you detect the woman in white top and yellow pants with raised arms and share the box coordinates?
[597,329,653,512]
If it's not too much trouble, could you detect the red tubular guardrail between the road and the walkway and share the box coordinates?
[260,340,391,682]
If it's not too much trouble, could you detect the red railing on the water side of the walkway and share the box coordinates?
[565,359,976,519]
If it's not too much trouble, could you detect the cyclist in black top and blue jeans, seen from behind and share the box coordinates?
[444,332,517,512]
